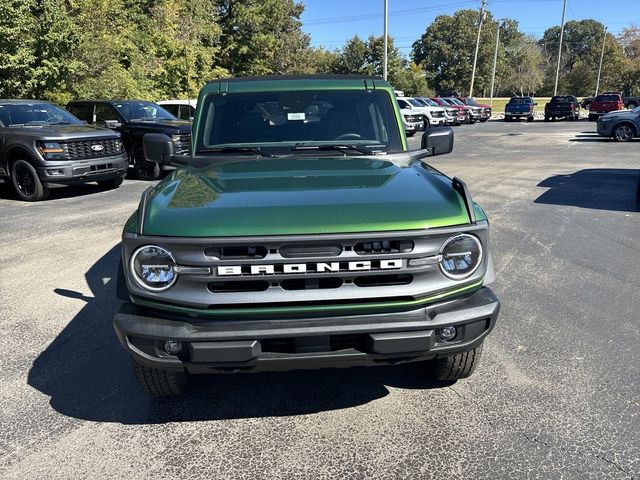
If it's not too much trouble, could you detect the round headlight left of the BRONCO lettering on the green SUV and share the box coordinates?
[130,245,178,292]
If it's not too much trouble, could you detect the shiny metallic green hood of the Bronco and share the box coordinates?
[143,157,469,237]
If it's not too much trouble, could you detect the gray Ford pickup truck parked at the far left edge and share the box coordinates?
[0,100,128,202]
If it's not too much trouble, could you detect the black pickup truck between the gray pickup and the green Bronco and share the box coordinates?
[67,100,191,180]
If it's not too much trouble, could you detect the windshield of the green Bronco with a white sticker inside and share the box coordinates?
[196,90,403,154]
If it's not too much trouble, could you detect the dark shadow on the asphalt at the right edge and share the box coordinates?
[535,168,640,212]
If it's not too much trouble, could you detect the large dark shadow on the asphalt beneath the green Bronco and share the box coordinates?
[28,245,444,424]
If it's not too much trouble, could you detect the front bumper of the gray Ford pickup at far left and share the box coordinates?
[38,153,128,185]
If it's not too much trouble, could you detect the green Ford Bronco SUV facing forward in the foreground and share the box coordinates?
[114,76,500,396]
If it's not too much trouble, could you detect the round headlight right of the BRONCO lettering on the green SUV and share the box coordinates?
[440,233,482,280]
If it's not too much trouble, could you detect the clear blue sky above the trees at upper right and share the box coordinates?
[300,0,640,54]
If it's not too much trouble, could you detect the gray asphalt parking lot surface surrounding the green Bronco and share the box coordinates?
[0,121,640,479]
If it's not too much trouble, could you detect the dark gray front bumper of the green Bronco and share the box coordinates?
[113,287,500,373]
